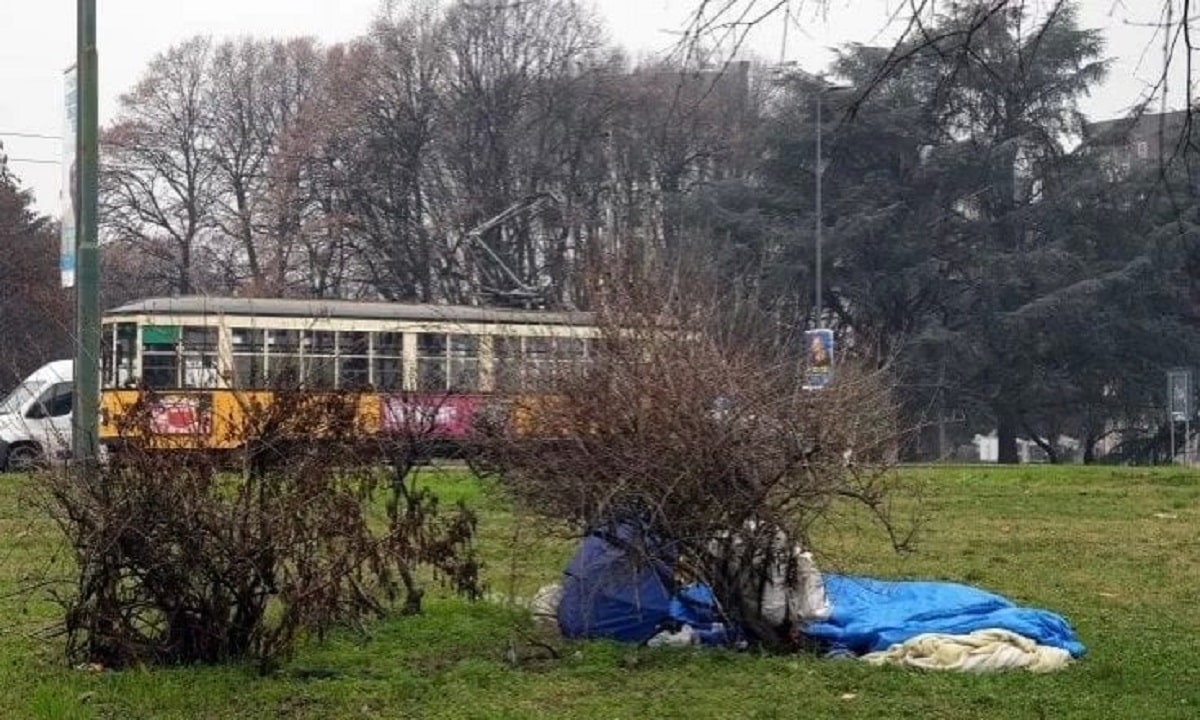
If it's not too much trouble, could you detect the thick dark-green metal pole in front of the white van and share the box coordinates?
[71,0,100,468]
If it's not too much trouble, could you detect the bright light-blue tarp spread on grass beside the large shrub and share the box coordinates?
[804,575,1085,658]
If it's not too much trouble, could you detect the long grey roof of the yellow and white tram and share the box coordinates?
[104,295,595,325]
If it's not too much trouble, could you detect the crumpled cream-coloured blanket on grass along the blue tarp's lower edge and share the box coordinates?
[862,628,1070,672]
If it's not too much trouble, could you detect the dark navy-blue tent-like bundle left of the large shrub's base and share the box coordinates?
[558,523,674,642]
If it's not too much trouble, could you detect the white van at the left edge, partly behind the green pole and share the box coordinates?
[0,360,74,470]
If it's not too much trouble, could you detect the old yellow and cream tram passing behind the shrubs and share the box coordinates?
[100,296,599,450]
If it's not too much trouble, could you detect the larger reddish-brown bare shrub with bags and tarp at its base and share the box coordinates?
[478,272,906,648]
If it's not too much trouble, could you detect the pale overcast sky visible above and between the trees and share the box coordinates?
[0,0,1183,212]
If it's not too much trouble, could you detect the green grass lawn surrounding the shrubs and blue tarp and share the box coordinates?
[0,467,1200,720]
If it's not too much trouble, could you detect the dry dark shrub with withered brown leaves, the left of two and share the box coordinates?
[48,391,479,668]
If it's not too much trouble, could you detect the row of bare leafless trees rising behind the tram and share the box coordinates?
[96,0,768,305]
